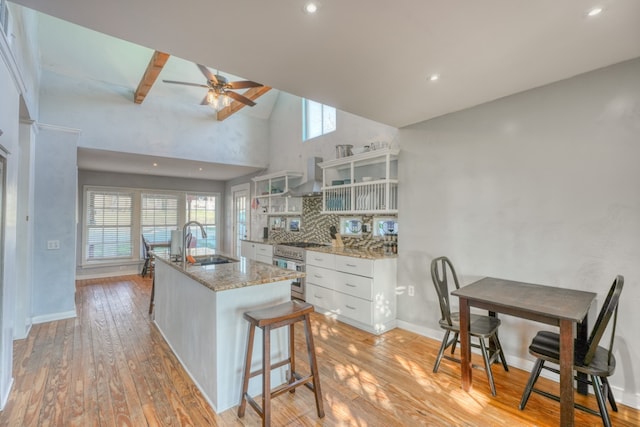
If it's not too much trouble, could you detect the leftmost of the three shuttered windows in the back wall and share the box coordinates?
[85,190,133,261]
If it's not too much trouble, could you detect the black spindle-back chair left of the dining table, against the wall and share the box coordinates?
[431,257,509,396]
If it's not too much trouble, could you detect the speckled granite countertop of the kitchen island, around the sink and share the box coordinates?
[155,249,305,292]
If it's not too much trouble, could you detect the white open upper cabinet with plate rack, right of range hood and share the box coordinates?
[320,148,399,214]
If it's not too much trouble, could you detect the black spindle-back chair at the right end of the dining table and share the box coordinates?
[520,275,624,427]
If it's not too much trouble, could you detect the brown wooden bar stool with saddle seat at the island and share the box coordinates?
[238,301,324,426]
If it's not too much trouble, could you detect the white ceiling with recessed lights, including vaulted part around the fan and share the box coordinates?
[8,0,640,179]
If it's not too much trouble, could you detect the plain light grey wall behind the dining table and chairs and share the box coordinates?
[398,59,640,407]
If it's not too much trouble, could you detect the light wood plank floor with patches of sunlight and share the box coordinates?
[0,276,640,427]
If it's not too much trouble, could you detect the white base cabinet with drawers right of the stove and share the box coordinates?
[306,251,397,334]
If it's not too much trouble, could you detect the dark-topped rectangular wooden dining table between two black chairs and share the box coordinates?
[451,277,596,426]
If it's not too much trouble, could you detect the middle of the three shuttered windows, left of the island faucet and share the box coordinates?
[140,193,178,250]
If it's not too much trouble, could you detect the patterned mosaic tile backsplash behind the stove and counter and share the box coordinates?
[265,196,392,250]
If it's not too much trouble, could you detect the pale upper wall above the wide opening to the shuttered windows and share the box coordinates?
[40,71,268,166]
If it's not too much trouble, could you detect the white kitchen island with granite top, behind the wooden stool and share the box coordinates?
[154,251,304,412]
